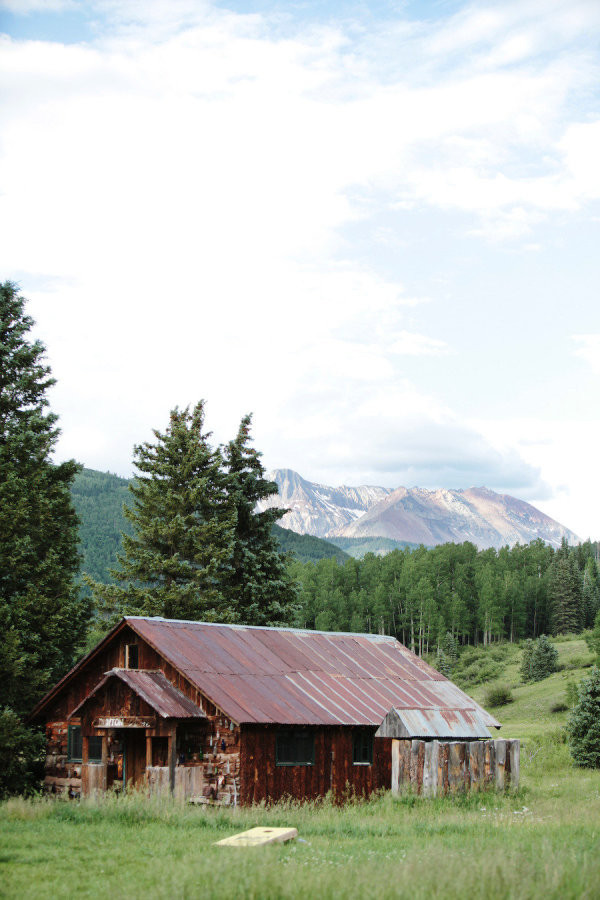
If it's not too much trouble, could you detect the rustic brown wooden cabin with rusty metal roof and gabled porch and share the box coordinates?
[30,616,500,804]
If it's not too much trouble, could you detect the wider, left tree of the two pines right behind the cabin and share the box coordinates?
[88,401,238,624]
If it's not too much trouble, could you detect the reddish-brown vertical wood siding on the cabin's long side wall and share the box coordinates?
[240,725,391,805]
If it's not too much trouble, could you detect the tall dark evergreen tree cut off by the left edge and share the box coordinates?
[0,282,89,715]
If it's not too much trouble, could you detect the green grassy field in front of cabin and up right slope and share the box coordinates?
[0,641,600,900]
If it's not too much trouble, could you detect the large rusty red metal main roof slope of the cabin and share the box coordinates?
[125,616,500,727]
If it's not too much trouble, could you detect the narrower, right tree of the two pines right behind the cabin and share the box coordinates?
[223,415,297,625]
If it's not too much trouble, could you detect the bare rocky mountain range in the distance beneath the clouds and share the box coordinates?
[255,469,579,553]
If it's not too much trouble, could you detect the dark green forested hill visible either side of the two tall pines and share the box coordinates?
[72,469,349,582]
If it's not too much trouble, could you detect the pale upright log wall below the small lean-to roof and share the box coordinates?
[391,740,520,797]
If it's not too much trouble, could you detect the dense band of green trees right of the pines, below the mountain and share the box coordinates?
[290,540,600,655]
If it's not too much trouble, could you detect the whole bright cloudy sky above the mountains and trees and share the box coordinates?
[0,0,600,539]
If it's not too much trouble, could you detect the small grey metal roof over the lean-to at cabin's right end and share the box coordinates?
[376,708,492,740]
